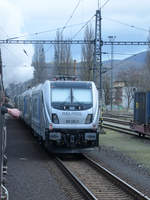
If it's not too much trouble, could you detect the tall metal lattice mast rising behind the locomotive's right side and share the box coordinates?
[93,9,103,102]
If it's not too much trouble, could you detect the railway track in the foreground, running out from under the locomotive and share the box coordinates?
[56,156,150,200]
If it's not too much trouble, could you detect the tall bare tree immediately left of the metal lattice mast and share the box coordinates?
[81,25,94,80]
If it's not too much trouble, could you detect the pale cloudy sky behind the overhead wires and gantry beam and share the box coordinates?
[0,0,150,85]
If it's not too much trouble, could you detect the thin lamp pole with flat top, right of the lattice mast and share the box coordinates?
[108,36,116,111]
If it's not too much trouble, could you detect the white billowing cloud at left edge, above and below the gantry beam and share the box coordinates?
[0,0,33,86]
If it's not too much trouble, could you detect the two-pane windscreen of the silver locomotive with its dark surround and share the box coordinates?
[51,82,93,110]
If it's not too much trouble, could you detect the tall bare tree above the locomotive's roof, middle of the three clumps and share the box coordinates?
[54,31,72,75]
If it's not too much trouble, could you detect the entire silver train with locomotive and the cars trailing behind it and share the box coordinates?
[19,80,100,153]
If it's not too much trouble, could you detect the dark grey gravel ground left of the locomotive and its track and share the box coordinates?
[7,120,68,200]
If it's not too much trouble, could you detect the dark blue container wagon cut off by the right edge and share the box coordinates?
[130,92,150,135]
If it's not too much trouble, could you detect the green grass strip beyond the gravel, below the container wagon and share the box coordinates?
[100,130,150,169]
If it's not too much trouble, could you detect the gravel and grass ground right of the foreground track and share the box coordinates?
[89,131,150,197]
